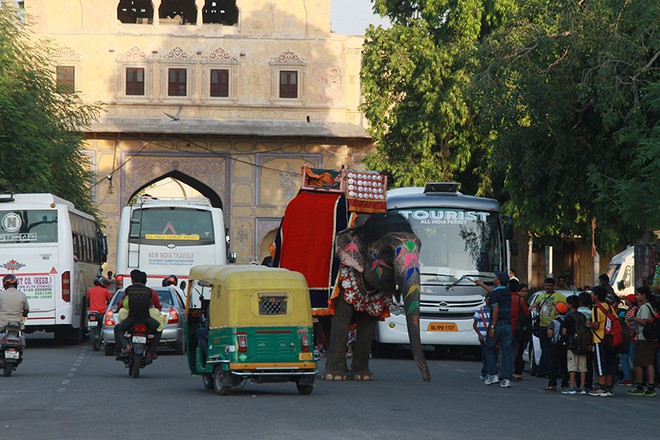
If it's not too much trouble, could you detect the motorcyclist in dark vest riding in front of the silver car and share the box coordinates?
[115,269,162,360]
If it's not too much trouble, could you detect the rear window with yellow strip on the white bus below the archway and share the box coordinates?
[129,206,215,246]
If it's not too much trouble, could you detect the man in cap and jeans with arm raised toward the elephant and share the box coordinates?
[474,271,513,388]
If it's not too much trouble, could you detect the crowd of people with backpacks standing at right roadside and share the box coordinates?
[473,272,660,397]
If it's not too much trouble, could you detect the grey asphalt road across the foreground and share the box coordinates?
[0,338,660,440]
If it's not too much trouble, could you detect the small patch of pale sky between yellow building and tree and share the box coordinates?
[330,0,388,35]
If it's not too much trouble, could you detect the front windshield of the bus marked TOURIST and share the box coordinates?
[393,208,504,277]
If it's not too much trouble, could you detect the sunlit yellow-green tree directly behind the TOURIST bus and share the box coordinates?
[361,0,515,193]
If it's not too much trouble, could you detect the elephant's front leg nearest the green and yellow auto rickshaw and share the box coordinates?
[323,289,355,380]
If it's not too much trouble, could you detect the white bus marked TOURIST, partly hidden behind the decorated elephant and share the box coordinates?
[376,183,510,351]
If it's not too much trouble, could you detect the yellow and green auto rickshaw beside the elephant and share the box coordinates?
[185,265,317,395]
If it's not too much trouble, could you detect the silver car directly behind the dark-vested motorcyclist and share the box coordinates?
[103,286,186,356]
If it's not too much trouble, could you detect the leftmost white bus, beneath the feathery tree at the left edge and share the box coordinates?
[0,194,107,343]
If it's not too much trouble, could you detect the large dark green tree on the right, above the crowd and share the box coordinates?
[475,0,660,251]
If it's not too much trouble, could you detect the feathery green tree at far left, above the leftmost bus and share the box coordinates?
[0,2,100,214]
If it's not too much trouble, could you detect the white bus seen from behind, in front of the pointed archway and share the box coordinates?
[116,197,228,289]
